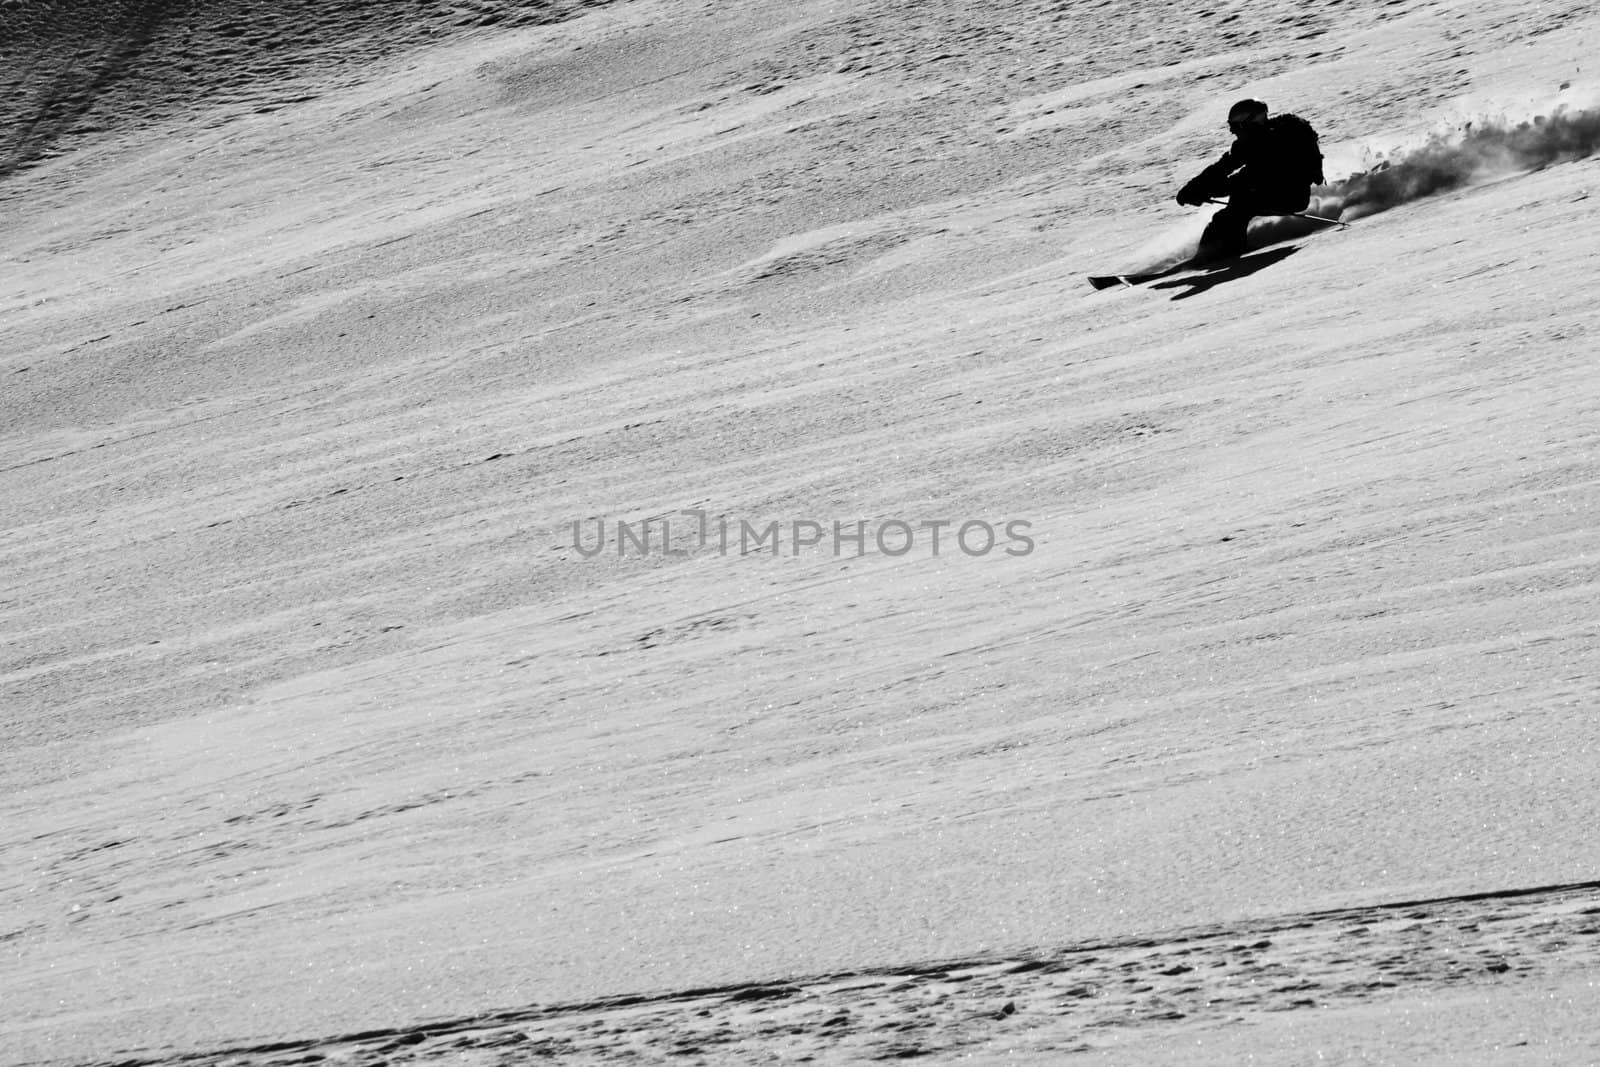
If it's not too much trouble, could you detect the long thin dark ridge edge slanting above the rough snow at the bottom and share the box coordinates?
[53,880,1600,1067]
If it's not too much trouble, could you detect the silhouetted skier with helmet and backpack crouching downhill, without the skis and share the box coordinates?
[1178,101,1323,261]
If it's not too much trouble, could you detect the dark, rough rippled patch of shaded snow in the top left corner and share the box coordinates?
[0,0,636,181]
